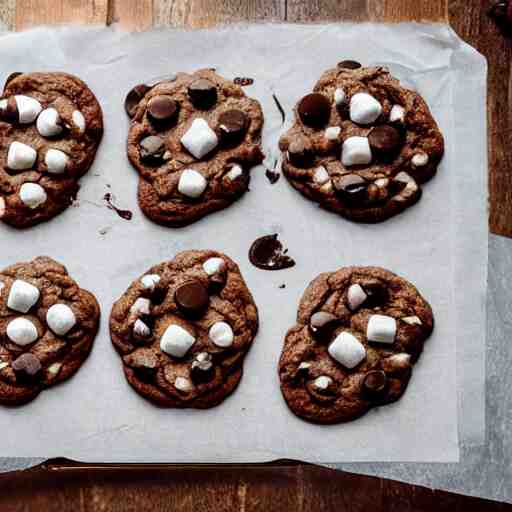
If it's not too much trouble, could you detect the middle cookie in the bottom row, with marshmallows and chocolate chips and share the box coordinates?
[110,251,258,408]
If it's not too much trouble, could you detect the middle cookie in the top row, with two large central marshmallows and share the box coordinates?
[125,69,263,227]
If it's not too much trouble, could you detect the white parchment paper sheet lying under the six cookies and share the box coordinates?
[0,24,487,462]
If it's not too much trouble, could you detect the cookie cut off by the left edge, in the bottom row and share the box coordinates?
[0,256,100,405]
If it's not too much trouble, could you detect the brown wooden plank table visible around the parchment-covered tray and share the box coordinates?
[0,0,512,512]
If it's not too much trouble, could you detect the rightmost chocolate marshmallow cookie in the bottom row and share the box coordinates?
[279,267,434,423]
